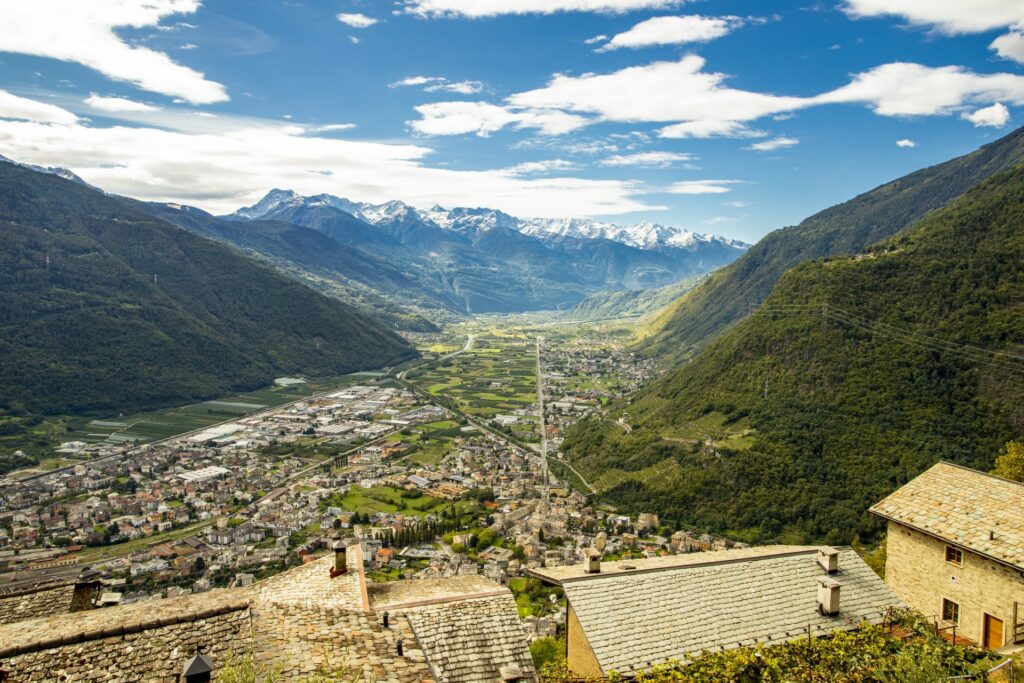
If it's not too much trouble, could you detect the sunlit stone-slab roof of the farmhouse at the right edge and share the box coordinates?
[871,463,1024,569]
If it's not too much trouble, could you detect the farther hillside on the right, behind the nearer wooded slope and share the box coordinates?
[643,129,1024,358]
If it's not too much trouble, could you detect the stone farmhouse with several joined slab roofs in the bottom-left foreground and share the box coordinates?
[0,545,537,683]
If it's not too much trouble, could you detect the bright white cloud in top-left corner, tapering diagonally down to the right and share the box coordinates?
[0,0,228,104]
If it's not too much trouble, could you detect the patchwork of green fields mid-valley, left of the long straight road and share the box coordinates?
[407,329,540,441]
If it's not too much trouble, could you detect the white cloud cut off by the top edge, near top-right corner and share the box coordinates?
[844,0,1024,35]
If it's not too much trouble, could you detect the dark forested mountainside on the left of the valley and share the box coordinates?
[0,163,415,414]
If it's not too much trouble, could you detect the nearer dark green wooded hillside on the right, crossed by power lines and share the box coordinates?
[566,161,1024,543]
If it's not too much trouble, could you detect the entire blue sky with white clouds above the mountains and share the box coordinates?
[0,0,1024,241]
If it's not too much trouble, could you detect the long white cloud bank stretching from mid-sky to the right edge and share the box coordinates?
[410,54,1024,141]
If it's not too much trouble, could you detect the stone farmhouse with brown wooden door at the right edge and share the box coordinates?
[871,463,1024,650]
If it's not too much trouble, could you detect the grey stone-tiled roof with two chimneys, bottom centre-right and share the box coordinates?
[561,547,902,674]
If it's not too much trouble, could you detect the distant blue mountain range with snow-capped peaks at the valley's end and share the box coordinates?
[211,189,746,314]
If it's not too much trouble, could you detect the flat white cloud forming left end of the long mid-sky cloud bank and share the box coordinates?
[409,101,587,137]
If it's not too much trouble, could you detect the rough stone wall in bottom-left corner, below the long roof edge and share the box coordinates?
[3,608,252,683]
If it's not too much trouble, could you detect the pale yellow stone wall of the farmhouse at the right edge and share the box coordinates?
[886,521,1024,643]
